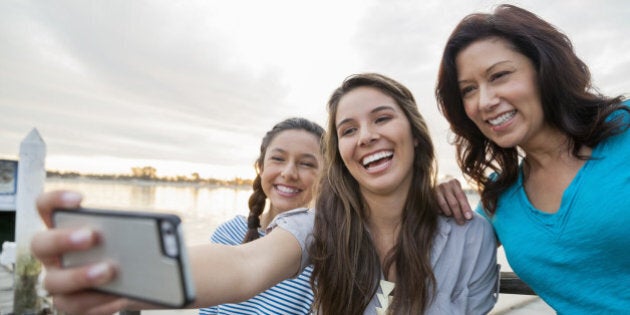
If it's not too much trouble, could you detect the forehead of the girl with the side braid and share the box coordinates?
[267,129,320,155]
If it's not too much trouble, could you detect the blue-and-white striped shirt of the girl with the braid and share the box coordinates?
[199,215,313,315]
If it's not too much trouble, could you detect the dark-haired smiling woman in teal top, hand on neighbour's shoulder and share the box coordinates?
[436,5,630,314]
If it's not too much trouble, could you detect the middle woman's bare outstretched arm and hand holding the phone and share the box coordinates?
[31,191,301,315]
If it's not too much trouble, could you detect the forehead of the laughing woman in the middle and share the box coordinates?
[335,86,399,123]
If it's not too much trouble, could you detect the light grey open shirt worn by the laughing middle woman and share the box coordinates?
[268,208,499,315]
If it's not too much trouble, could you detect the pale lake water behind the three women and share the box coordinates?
[45,178,555,315]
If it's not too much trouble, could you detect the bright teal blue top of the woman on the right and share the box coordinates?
[477,107,630,315]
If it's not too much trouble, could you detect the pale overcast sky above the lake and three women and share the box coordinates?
[0,0,630,178]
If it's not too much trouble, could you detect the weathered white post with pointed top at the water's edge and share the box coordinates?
[13,129,46,314]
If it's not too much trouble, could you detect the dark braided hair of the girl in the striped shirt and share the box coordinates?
[243,118,324,243]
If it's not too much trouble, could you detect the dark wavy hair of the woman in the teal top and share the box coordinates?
[435,4,628,214]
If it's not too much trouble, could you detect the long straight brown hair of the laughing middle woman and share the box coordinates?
[309,73,438,314]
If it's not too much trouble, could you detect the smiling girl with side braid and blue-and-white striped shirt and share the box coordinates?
[199,118,324,315]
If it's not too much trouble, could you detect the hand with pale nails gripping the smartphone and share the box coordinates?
[31,191,128,314]
